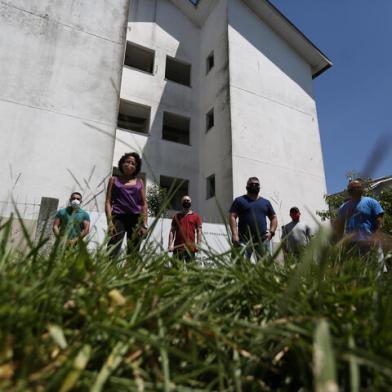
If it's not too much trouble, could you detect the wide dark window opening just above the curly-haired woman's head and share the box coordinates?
[117,99,151,134]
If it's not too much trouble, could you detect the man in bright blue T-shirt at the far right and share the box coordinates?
[337,180,384,255]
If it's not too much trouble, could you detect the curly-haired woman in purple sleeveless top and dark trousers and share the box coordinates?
[105,152,147,257]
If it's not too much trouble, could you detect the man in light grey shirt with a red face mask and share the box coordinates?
[282,207,311,256]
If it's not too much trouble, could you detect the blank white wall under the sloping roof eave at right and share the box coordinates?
[228,0,326,233]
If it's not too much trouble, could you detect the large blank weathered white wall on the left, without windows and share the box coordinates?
[0,0,128,216]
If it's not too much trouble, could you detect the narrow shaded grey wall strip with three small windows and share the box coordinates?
[199,0,233,222]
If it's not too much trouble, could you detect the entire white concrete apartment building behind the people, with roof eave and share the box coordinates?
[0,0,331,248]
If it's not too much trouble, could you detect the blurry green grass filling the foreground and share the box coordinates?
[0,217,392,392]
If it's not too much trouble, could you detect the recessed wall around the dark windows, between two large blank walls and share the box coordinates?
[113,0,232,222]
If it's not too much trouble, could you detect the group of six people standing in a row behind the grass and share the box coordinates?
[53,152,384,260]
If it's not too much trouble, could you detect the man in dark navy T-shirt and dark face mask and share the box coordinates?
[229,177,278,259]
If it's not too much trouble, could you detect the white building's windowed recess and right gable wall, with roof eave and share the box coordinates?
[114,0,331,233]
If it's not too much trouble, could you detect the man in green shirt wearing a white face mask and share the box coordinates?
[53,192,90,245]
